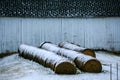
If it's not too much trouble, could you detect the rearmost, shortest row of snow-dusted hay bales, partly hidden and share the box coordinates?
[59,42,96,57]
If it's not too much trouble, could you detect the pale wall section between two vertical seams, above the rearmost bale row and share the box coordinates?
[62,18,84,45]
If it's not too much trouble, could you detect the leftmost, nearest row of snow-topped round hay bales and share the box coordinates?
[18,44,76,74]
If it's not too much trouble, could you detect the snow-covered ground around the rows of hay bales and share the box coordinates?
[0,51,120,80]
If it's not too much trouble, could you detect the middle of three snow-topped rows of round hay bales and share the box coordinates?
[40,42,102,72]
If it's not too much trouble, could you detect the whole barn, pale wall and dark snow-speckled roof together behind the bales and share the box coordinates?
[0,0,120,53]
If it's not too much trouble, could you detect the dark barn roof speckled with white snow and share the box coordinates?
[0,0,120,17]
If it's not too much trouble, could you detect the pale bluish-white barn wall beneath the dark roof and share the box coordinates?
[0,17,120,53]
